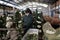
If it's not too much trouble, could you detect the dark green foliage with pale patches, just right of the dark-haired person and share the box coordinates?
[33,9,44,28]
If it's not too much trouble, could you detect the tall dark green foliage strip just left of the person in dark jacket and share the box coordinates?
[15,11,23,40]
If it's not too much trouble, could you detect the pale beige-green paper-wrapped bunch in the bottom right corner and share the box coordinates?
[42,22,60,40]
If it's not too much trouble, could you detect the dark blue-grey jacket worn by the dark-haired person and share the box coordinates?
[23,14,33,27]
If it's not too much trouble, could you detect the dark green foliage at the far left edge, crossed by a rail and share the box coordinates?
[0,15,7,37]
